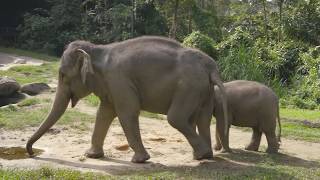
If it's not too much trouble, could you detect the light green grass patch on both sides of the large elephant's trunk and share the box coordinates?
[0,104,94,130]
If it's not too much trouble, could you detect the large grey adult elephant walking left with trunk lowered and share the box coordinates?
[27,37,227,163]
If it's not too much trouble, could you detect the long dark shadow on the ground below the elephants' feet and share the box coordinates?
[35,149,320,179]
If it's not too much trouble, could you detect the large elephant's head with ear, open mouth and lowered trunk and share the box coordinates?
[26,41,94,155]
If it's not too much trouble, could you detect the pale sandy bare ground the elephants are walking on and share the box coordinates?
[0,53,320,174]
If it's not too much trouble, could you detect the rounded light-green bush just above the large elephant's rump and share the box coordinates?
[183,31,218,59]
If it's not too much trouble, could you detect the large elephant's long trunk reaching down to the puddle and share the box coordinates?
[26,85,70,156]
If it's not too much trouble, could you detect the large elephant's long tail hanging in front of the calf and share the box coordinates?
[211,74,229,136]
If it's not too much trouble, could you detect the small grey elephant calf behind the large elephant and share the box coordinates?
[213,80,281,153]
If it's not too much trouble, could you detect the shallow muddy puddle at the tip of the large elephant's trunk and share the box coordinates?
[0,147,44,160]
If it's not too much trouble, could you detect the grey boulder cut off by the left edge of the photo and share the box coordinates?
[0,76,20,97]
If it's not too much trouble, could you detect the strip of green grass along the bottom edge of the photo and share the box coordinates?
[0,150,320,180]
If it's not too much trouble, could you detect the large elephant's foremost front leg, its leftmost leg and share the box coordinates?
[86,103,116,158]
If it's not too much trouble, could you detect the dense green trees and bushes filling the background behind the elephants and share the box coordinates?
[0,0,320,109]
